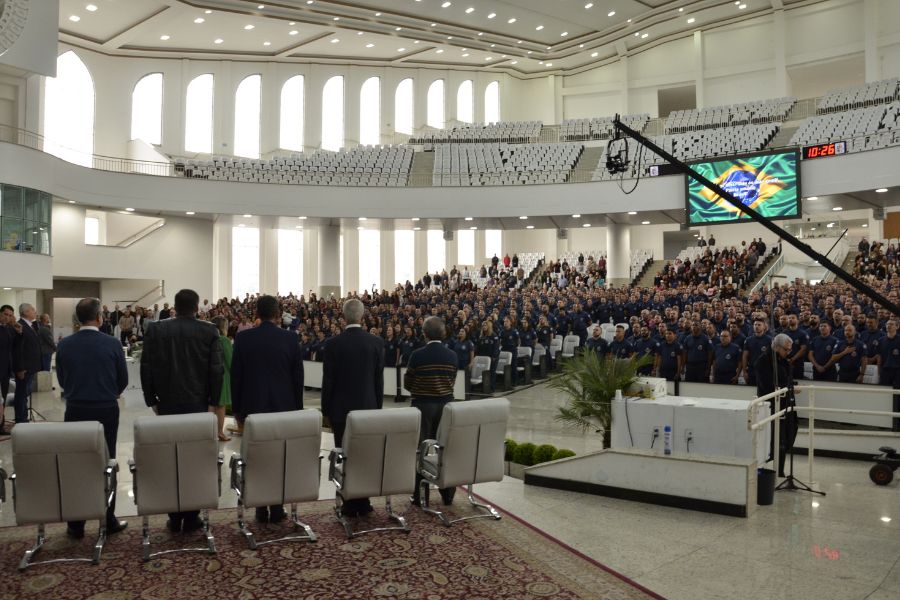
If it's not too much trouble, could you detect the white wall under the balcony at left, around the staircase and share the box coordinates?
[53,203,213,302]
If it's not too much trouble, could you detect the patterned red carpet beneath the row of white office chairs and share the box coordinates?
[0,494,659,600]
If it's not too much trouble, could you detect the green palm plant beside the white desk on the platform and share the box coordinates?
[549,351,653,448]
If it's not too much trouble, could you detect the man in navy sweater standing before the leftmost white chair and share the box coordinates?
[56,298,128,539]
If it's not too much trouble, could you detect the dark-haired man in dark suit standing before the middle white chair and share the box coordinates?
[231,296,303,523]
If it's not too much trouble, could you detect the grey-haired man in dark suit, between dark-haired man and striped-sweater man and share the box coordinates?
[322,298,384,517]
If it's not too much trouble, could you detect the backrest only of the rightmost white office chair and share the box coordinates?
[437,398,509,488]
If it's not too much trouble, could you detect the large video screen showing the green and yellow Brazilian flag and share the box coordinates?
[685,150,800,225]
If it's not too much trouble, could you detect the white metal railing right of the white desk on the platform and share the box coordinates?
[747,385,900,483]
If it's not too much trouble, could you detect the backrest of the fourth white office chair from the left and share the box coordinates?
[341,407,421,500]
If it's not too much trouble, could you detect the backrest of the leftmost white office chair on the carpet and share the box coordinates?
[12,421,109,525]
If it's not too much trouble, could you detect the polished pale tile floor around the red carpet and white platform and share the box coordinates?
[0,378,900,600]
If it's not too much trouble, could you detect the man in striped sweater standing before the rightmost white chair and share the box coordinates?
[403,317,457,506]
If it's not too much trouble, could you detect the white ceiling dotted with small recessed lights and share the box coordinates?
[59,0,819,76]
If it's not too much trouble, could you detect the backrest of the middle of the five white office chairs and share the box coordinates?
[241,410,322,506]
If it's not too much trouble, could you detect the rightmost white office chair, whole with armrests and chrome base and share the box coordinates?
[416,398,509,527]
